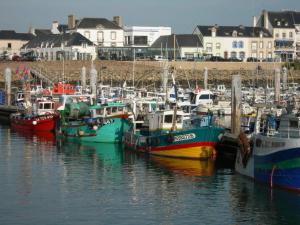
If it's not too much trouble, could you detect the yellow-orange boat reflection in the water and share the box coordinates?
[150,156,215,177]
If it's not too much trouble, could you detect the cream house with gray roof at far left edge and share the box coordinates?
[0,30,34,57]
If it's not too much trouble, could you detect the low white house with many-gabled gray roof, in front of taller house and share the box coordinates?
[22,32,97,61]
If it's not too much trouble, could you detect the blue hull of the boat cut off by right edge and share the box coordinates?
[236,135,300,192]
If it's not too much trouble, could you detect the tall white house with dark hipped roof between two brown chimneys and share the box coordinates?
[68,15,124,47]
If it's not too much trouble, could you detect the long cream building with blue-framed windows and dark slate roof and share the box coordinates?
[193,24,273,61]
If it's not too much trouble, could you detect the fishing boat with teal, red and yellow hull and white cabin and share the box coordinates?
[124,110,224,159]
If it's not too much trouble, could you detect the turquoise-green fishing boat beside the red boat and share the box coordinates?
[61,103,130,143]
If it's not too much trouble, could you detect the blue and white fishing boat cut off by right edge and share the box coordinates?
[235,110,300,192]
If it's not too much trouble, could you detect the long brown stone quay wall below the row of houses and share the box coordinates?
[0,60,300,87]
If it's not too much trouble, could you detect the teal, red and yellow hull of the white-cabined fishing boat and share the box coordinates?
[125,127,224,159]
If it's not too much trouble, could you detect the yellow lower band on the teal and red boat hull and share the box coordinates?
[149,146,216,159]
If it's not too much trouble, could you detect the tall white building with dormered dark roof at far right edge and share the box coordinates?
[253,10,300,61]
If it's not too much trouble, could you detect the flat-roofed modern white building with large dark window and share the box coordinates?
[124,26,172,47]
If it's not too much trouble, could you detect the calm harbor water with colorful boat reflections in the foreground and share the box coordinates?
[0,126,300,225]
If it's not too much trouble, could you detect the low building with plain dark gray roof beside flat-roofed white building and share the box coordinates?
[150,34,203,60]
